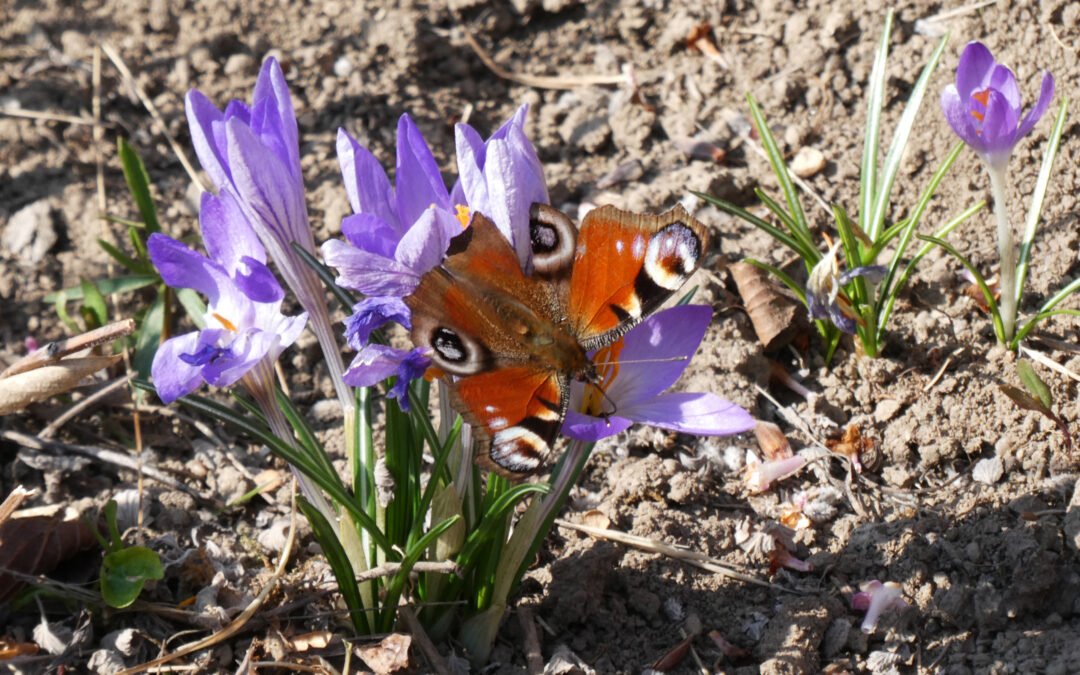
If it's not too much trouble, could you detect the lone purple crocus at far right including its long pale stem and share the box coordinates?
[942,42,1054,342]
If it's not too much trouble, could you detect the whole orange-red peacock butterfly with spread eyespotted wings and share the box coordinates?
[405,204,708,478]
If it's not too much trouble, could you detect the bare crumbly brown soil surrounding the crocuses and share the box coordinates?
[0,0,1080,675]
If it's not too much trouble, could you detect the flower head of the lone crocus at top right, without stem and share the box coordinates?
[942,42,1054,167]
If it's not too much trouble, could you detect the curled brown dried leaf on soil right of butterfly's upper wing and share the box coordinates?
[728,262,808,352]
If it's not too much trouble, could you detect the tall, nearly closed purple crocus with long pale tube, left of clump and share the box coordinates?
[185,58,353,410]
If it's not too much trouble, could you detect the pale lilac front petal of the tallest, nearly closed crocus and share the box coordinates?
[226,120,314,257]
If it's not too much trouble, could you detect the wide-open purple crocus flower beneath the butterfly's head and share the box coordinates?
[563,305,754,441]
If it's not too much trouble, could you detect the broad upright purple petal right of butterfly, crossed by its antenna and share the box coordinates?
[607,305,713,405]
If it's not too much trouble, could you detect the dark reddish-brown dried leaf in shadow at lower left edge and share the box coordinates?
[0,516,97,603]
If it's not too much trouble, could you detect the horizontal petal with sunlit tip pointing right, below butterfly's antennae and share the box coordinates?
[617,393,754,436]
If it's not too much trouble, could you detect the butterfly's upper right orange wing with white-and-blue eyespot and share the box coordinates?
[568,206,708,349]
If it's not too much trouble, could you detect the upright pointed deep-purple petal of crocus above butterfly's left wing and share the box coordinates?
[394,114,450,227]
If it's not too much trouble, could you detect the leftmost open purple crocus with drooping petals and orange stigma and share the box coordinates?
[147,192,308,403]
